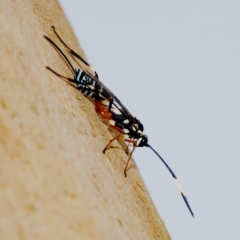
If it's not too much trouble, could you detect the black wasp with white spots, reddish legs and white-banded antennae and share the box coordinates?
[44,26,194,217]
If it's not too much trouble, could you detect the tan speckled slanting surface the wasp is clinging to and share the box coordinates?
[0,0,170,240]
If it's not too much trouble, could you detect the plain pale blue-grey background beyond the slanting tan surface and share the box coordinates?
[60,0,240,240]
